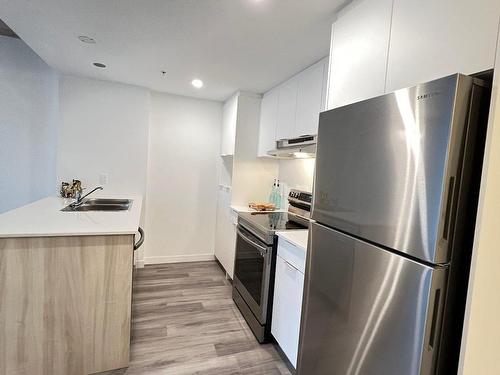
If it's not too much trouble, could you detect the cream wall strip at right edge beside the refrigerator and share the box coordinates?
[459,25,500,375]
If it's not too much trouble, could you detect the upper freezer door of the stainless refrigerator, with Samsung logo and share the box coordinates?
[313,75,472,263]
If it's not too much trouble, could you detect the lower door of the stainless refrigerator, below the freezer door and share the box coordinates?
[298,224,447,375]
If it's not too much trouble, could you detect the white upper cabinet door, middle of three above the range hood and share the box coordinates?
[276,77,298,140]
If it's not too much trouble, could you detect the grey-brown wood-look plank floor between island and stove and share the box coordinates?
[103,262,290,375]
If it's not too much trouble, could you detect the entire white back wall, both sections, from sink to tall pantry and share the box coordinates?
[57,76,222,264]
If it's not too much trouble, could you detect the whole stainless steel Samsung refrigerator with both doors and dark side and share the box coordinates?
[297,74,490,375]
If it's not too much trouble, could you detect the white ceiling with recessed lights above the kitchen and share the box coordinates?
[0,0,345,100]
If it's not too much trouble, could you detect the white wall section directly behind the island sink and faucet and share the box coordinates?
[57,76,150,196]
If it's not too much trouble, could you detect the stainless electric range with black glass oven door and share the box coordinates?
[233,190,312,342]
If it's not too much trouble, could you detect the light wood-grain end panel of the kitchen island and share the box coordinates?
[0,235,134,375]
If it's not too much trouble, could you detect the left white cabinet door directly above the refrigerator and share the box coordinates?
[328,0,394,109]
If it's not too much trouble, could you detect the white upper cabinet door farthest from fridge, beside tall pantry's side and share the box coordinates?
[258,89,279,156]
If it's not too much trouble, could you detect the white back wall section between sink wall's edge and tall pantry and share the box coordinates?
[145,93,222,263]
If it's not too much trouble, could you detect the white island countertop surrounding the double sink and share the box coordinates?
[0,194,142,238]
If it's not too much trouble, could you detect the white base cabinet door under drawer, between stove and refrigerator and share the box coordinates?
[271,257,304,368]
